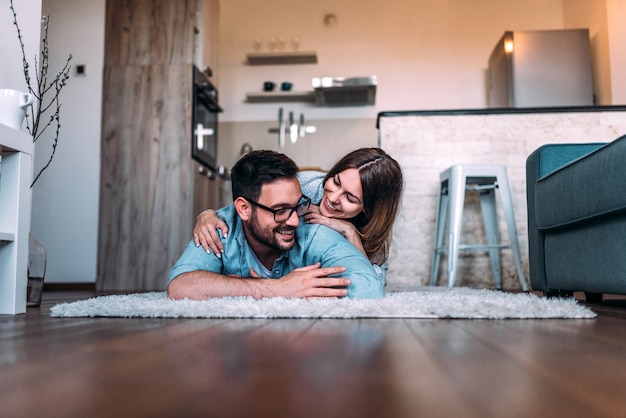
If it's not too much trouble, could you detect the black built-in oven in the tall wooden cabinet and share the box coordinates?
[191,66,222,172]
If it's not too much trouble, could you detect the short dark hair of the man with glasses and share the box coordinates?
[230,150,298,200]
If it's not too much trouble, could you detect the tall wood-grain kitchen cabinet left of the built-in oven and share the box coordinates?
[96,0,218,291]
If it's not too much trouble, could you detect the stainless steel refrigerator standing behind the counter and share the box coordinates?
[488,29,594,108]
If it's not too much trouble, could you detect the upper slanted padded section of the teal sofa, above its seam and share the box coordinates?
[535,135,626,230]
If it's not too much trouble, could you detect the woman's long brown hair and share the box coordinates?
[324,148,404,265]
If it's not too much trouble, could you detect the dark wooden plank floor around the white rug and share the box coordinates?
[0,291,626,418]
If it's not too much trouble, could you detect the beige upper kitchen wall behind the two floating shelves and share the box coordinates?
[219,0,564,121]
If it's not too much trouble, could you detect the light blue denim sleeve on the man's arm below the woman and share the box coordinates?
[302,225,385,299]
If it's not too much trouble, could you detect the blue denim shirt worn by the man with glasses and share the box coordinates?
[168,204,385,299]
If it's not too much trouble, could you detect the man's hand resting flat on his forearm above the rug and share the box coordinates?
[250,263,350,299]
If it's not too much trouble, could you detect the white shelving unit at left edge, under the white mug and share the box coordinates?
[0,124,34,315]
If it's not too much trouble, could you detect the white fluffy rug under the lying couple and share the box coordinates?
[51,287,596,319]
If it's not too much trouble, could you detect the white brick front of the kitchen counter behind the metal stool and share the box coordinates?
[379,108,626,290]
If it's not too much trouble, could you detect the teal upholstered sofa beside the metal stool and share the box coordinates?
[526,135,626,302]
